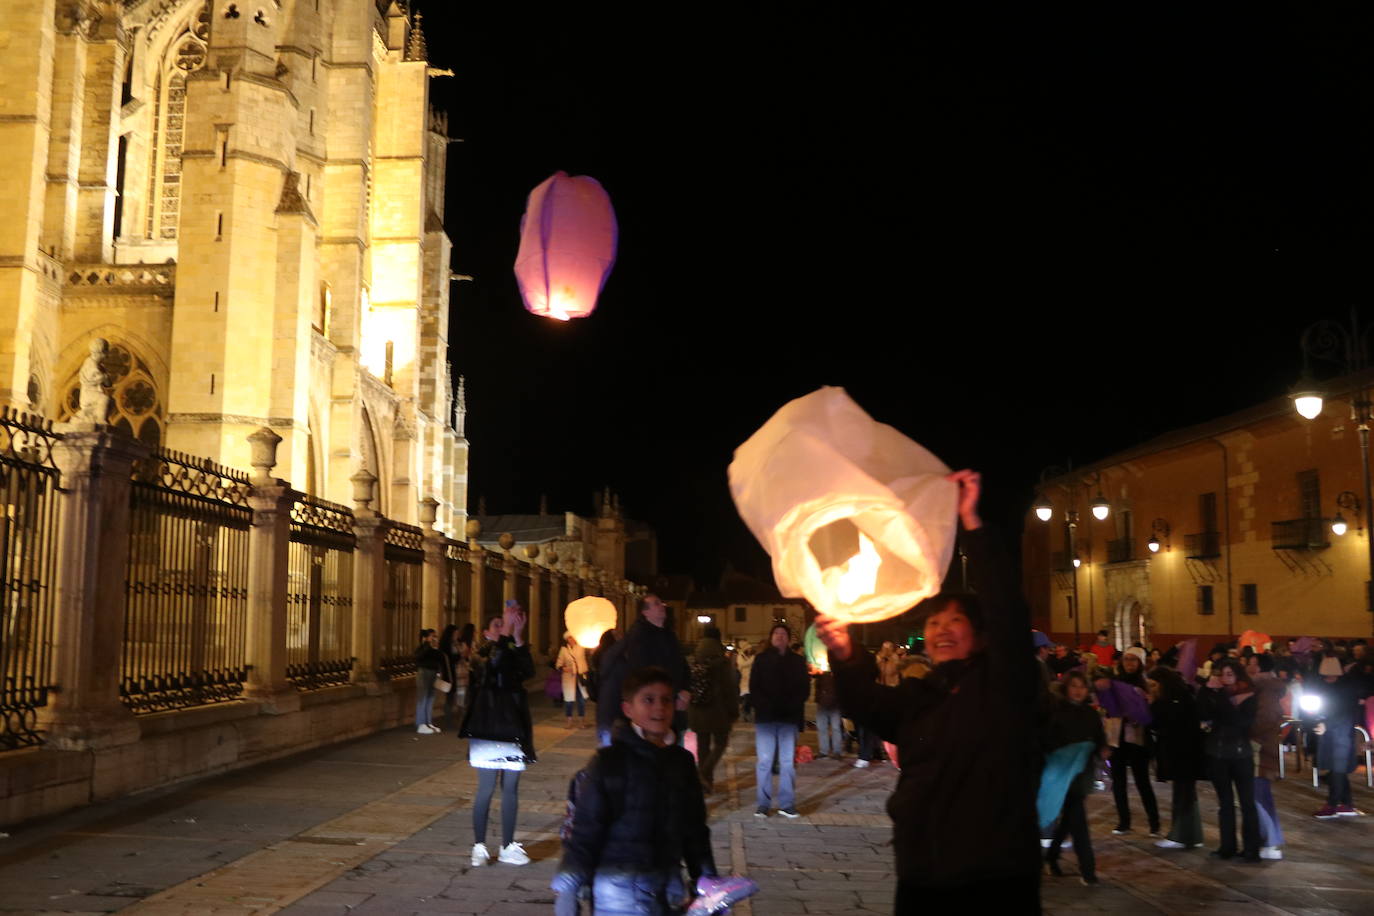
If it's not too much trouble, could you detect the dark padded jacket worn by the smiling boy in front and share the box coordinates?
[555,722,716,893]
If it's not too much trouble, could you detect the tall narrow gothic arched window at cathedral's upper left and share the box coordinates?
[146,4,210,239]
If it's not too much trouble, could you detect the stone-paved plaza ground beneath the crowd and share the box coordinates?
[0,700,1374,916]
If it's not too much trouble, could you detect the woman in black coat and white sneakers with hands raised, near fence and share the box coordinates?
[459,599,536,868]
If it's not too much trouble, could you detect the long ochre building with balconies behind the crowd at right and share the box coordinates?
[1022,376,1371,647]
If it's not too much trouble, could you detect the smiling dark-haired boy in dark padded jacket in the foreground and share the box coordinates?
[552,667,758,915]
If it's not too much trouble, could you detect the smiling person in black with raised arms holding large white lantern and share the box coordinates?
[816,471,1044,916]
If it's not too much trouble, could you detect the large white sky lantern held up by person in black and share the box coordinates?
[730,387,958,623]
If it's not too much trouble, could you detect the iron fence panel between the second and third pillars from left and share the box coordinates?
[286,496,357,689]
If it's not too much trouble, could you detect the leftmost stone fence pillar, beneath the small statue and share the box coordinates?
[38,420,147,751]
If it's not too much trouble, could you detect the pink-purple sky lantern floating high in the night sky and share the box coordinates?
[515,172,617,321]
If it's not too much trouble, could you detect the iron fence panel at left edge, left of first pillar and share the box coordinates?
[0,408,62,750]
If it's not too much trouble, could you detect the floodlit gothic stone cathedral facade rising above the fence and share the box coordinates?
[0,0,467,537]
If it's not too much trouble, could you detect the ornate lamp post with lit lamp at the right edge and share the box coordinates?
[1289,308,1374,637]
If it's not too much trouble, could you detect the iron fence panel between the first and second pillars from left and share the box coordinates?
[120,450,253,713]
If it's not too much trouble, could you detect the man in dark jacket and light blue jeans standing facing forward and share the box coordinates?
[749,623,811,817]
